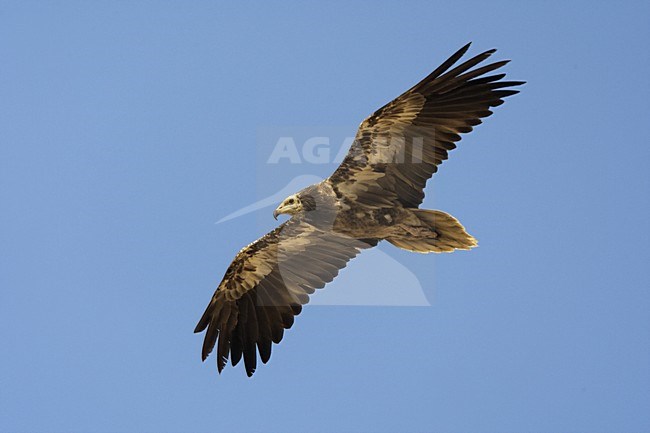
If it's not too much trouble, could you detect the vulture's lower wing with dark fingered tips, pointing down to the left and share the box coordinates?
[194,217,377,376]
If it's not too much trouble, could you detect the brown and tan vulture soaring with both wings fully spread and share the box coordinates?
[194,44,524,376]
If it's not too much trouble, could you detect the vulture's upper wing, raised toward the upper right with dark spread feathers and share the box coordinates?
[328,44,523,207]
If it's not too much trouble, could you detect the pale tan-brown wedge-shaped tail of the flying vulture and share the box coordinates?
[386,209,478,253]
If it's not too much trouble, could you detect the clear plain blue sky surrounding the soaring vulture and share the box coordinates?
[0,1,650,432]
